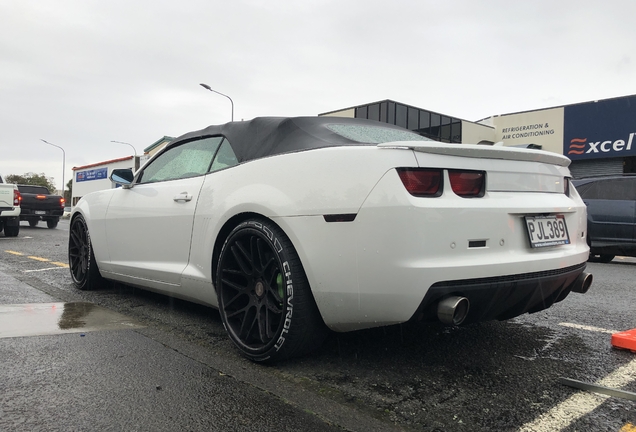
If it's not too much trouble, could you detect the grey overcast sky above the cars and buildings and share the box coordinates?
[0,0,636,188]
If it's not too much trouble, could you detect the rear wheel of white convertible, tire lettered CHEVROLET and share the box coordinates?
[216,219,328,362]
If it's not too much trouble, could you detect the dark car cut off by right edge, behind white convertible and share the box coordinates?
[572,174,636,263]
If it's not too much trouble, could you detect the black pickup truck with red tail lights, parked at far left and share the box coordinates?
[18,185,64,228]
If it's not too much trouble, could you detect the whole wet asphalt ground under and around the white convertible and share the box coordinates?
[0,221,636,432]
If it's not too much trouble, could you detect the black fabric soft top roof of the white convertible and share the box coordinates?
[167,117,415,162]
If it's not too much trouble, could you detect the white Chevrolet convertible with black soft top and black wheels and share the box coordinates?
[69,117,592,361]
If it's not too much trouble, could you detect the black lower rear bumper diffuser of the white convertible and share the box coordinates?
[412,264,586,323]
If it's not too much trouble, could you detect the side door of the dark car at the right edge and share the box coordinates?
[582,178,636,247]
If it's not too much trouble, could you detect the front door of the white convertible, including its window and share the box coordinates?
[105,137,223,285]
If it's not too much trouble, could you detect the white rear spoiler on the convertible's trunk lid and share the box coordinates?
[378,141,571,167]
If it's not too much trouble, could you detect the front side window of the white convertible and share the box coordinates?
[139,137,223,183]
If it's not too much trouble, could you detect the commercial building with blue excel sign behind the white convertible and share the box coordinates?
[320,95,636,178]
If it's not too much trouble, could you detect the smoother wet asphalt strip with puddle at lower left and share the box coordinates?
[0,273,352,431]
